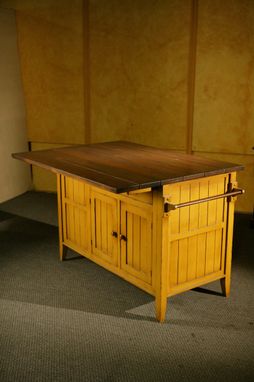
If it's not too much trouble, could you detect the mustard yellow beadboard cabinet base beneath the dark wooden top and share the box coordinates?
[57,173,236,322]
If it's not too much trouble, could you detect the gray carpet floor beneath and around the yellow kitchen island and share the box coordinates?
[0,192,254,382]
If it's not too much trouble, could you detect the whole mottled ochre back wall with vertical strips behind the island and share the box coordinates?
[0,0,254,211]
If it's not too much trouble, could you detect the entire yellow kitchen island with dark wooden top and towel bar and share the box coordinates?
[13,141,243,322]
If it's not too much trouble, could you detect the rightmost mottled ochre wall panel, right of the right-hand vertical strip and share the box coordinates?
[193,0,254,154]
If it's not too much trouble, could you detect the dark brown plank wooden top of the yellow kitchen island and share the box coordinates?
[13,141,243,193]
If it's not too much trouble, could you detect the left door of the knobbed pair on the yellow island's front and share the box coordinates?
[91,190,118,265]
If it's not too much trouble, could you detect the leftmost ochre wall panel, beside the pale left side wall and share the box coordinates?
[16,0,85,143]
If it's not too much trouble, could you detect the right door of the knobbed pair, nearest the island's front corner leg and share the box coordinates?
[120,202,152,284]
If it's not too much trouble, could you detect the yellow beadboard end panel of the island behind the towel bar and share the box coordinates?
[163,174,228,292]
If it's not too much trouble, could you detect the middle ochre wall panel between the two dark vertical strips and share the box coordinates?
[89,0,191,149]
